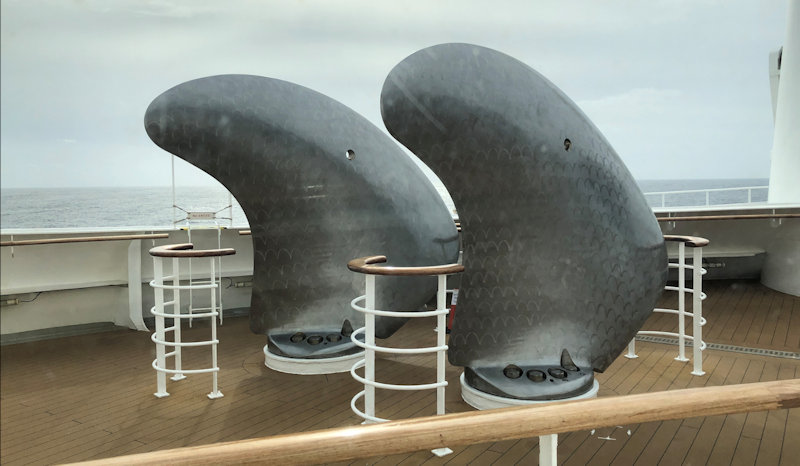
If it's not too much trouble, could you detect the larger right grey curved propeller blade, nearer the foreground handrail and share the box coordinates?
[381,44,667,399]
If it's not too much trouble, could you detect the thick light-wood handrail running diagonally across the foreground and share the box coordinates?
[70,379,800,465]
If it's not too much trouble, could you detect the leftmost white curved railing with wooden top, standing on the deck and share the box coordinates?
[150,243,236,399]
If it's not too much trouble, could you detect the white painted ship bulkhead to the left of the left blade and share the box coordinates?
[0,228,253,336]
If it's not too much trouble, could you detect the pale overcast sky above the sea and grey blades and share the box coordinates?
[0,0,786,188]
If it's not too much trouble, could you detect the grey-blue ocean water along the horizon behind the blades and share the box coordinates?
[0,179,768,229]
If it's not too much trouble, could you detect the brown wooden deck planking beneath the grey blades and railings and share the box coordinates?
[0,282,800,464]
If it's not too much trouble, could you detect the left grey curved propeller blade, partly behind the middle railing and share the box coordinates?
[145,75,458,357]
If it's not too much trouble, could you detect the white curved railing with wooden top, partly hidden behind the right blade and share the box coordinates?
[625,235,708,376]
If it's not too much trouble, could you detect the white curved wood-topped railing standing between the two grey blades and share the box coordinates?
[347,256,464,456]
